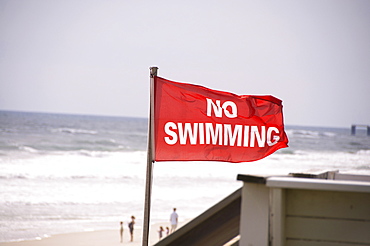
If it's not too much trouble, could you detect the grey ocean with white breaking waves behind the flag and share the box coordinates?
[0,111,370,242]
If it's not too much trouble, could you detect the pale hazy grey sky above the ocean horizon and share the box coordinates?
[0,0,370,127]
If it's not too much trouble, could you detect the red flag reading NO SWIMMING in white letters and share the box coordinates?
[154,77,288,162]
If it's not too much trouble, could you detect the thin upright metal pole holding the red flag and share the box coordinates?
[142,67,158,246]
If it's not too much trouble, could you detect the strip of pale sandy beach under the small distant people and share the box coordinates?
[0,222,185,246]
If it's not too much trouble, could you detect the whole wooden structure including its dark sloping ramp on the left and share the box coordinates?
[155,172,370,246]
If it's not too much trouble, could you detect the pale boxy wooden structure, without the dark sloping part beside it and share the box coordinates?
[238,172,370,246]
